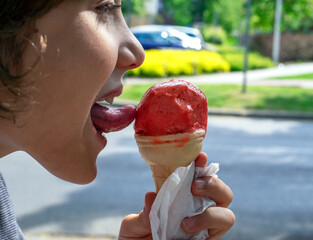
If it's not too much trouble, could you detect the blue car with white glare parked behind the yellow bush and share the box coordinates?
[131,25,202,50]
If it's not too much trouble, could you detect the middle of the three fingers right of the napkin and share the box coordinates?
[191,177,233,207]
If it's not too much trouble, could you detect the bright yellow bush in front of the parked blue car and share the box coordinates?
[128,49,230,77]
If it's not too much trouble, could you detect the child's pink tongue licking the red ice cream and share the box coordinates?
[91,104,136,133]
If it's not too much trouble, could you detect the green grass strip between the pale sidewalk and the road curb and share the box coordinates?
[120,84,313,112]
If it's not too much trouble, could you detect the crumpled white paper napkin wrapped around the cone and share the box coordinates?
[150,162,219,240]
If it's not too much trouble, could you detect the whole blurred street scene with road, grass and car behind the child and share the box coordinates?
[0,0,313,240]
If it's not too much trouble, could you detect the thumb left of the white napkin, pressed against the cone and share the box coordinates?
[119,192,156,239]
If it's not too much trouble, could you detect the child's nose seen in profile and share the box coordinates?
[117,26,145,70]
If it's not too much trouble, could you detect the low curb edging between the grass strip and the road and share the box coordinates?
[108,99,313,120]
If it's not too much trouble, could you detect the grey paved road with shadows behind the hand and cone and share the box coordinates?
[0,117,313,240]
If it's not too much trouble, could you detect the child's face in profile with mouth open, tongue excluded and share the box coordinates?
[12,0,144,183]
